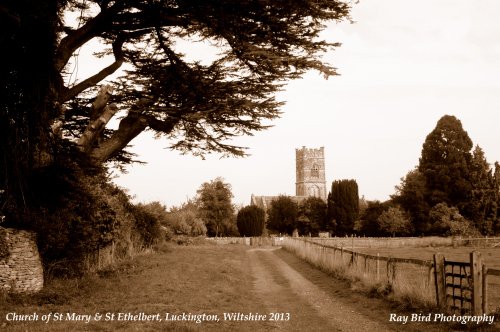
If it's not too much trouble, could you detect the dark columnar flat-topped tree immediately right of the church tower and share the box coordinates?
[328,180,359,235]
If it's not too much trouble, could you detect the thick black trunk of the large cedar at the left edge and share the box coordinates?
[0,0,67,210]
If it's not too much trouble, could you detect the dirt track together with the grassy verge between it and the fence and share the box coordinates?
[247,247,446,332]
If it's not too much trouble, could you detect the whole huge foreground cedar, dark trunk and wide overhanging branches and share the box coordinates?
[0,0,350,226]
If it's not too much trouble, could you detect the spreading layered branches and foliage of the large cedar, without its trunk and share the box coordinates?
[1,0,349,163]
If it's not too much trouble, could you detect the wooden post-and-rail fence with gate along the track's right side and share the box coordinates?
[282,238,500,314]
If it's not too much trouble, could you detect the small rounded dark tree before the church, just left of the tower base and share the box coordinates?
[267,195,299,235]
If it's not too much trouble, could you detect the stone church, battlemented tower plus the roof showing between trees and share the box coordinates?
[250,146,327,211]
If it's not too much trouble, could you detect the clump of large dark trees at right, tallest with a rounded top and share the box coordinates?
[392,115,500,235]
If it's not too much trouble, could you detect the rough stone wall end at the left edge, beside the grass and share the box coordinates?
[0,227,43,293]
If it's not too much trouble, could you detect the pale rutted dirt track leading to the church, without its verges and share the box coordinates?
[247,247,397,332]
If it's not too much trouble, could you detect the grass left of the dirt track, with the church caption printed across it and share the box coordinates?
[0,244,274,331]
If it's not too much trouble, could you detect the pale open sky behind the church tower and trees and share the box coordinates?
[69,0,500,208]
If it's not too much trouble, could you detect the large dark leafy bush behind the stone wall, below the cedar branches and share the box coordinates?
[24,164,119,275]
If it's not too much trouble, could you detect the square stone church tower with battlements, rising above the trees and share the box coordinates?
[295,146,326,202]
